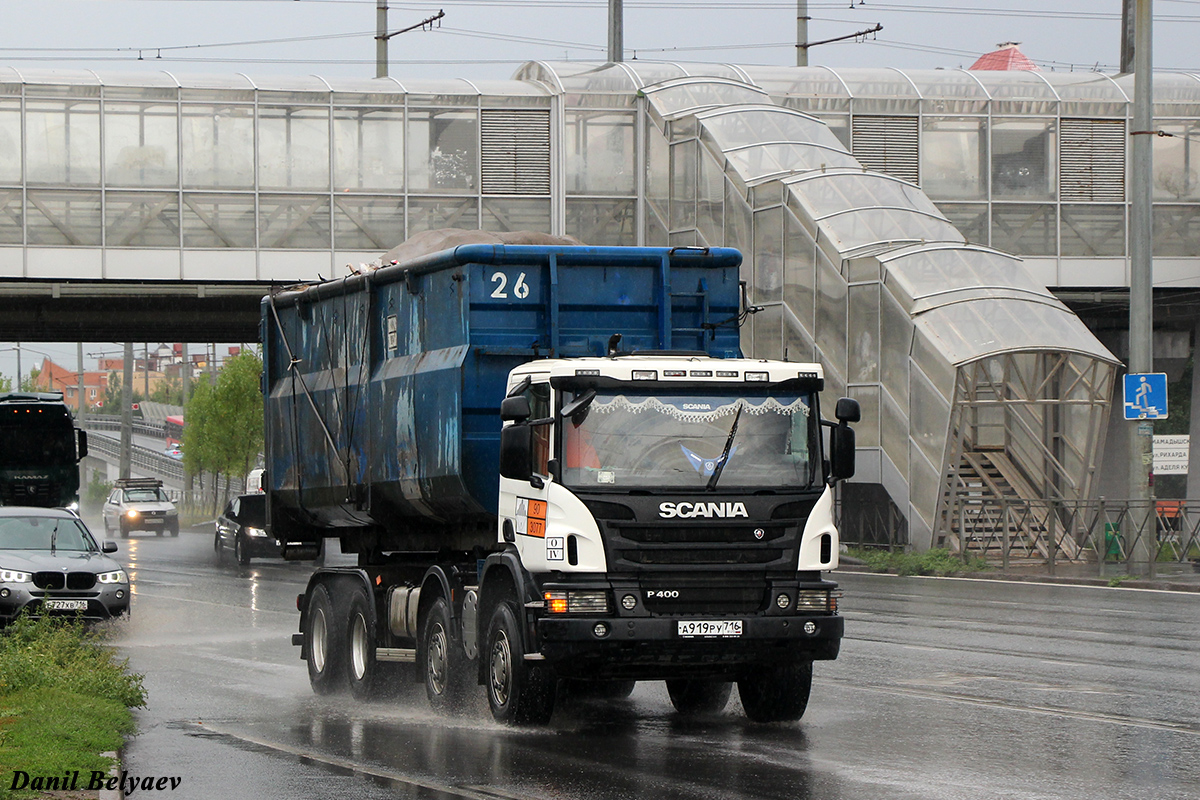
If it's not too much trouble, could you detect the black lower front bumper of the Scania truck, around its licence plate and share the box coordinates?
[534,614,844,680]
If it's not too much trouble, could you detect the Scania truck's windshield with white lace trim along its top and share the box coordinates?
[560,390,816,489]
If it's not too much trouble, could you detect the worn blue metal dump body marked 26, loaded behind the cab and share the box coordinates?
[262,245,742,546]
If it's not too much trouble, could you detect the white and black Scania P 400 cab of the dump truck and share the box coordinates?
[492,354,857,718]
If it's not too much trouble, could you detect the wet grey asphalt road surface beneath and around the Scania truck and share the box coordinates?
[108,531,1200,800]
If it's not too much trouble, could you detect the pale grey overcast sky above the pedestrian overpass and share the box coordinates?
[0,0,1200,377]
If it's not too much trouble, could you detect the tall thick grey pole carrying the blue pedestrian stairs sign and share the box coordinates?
[1129,0,1158,575]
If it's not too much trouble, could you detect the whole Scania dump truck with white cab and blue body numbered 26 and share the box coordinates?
[262,237,858,723]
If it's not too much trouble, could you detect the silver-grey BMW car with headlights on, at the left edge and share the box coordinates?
[0,506,130,627]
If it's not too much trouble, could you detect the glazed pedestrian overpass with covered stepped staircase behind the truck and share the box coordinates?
[0,61,1200,552]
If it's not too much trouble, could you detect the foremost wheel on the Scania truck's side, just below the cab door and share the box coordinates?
[487,601,558,724]
